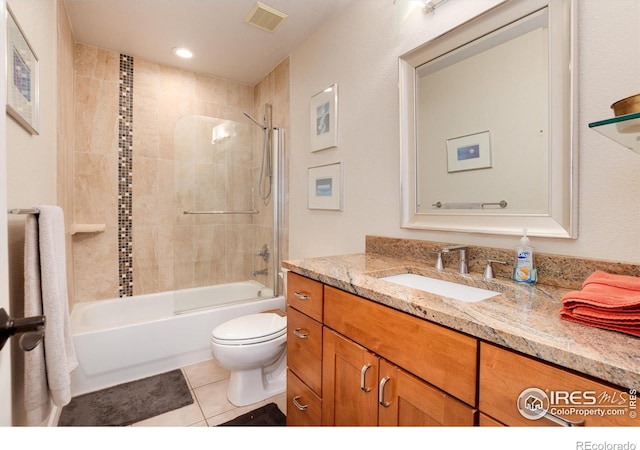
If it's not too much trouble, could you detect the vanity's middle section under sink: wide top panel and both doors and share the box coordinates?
[322,286,478,426]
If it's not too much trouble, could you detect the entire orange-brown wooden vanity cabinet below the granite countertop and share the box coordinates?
[287,272,640,426]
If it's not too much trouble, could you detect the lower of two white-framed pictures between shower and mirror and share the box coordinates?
[308,163,342,211]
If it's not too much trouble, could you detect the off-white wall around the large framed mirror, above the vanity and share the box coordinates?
[290,0,640,263]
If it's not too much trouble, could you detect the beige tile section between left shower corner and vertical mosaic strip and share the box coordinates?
[71,45,118,301]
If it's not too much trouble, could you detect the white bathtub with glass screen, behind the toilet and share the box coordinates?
[71,281,285,396]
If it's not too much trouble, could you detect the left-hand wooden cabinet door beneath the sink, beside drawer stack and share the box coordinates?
[322,327,379,426]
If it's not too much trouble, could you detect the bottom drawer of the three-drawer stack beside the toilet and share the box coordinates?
[287,370,322,427]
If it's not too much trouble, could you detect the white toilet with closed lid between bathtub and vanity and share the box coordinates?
[211,312,287,406]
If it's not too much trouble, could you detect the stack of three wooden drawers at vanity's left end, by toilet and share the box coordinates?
[287,272,324,426]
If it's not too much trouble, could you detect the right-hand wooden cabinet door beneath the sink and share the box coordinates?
[379,360,476,427]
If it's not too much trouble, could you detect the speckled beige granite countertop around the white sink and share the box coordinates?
[282,253,640,389]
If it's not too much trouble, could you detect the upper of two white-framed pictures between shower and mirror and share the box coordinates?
[310,83,338,152]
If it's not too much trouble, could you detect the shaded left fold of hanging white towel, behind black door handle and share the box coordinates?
[24,214,51,425]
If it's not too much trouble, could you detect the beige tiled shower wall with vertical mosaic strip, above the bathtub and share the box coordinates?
[73,44,289,302]
